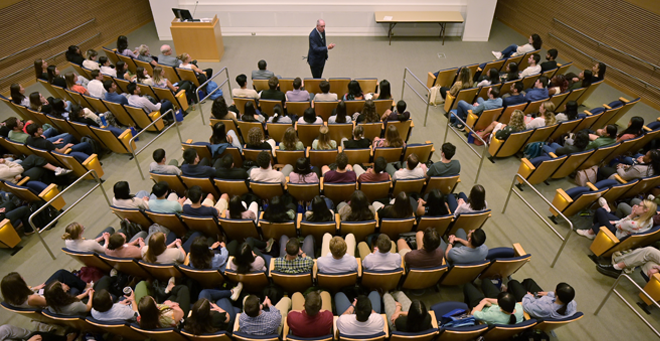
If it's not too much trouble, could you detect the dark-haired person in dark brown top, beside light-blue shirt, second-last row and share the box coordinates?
[397,227,445,268]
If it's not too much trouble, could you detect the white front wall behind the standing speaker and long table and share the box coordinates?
[150,0,476,39]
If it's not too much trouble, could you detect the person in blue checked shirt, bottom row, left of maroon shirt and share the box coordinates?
[238,295,291,336]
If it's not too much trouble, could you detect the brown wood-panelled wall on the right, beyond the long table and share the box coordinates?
[495,0,660,108]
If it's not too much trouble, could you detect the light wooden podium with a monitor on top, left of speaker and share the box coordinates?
[170,15,225,62]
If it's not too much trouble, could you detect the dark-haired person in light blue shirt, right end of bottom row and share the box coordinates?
[507,278,577,319]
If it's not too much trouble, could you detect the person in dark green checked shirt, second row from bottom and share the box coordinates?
[274,235,314,274]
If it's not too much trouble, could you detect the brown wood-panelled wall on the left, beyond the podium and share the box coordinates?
[0,0,153,93]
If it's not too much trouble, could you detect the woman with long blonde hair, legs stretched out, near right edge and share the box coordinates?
[576,198,658,239]
